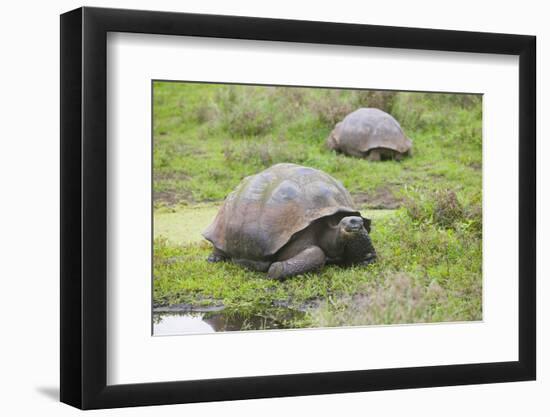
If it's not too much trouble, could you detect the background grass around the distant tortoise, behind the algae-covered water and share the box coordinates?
[153,82,481,204]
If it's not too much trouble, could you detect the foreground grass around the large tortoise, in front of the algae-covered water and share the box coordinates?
[154,209,481,327]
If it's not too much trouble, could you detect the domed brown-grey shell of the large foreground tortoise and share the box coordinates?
[203,163,360,260]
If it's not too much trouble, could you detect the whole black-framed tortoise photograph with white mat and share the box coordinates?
[60,7,536,409]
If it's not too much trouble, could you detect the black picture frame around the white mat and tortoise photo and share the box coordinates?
[60,7,536,409]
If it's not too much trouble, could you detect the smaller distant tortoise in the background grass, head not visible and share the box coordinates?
[327,108,412,161]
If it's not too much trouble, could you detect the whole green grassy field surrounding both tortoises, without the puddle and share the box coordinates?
[153,82,482,327]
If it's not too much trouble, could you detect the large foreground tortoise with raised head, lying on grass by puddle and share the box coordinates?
[203,164,376,279]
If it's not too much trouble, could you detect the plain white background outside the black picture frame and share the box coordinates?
[0,0,550,416]
